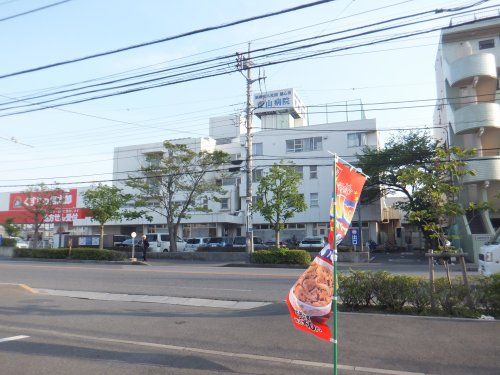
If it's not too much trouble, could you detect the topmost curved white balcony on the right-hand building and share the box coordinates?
[448,53,497,87]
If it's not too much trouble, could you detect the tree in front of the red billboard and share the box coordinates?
[21,183,65,248]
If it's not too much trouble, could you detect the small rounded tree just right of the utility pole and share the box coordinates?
[255,161,307,247]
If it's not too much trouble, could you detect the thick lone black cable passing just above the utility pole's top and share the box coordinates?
[0,0,336,79]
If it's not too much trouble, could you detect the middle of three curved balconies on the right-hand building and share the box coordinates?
[453,103,500,134]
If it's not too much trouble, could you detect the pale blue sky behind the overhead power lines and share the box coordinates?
[0,0,499,192]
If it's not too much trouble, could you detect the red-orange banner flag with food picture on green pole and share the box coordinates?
[286,162,366,341]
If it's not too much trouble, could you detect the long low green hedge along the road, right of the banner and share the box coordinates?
[339,270,500,318]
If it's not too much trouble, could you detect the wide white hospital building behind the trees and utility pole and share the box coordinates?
[84,89,399,247]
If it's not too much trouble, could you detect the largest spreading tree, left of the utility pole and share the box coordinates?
[126,141,230,251]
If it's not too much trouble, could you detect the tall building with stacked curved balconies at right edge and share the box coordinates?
[434,13,500,261]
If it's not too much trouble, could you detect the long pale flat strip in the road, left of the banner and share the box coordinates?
[37,288,271,310]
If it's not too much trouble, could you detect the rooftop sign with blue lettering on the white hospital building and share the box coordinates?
[253,89,306,118]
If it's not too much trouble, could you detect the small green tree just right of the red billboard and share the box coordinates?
[83,184,143,250]
